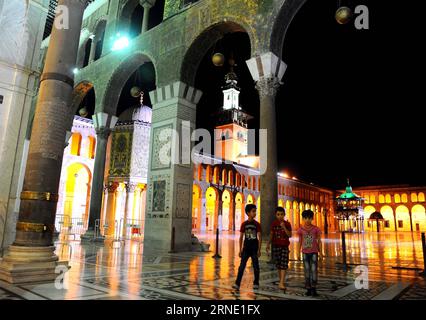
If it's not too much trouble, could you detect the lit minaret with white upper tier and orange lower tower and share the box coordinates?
[215,59,252,162]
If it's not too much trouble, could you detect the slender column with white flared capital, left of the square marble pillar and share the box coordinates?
[81,113,118,241]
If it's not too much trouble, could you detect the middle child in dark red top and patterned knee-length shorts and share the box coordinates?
[266,207,291,290]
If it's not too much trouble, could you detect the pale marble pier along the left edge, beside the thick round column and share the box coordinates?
[0,1,47,257]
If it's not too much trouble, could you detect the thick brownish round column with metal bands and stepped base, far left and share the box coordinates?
[0,0,87,283]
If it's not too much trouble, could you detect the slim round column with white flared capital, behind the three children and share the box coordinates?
[247,52,286,236]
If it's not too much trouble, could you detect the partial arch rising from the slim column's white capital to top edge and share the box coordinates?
[270,0,306,57]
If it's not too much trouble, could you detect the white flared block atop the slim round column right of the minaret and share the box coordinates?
[246,52,287,82]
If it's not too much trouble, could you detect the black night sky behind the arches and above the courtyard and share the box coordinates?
[196,0,426,189]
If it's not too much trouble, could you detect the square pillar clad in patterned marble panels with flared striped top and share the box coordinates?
[144,82,201,251]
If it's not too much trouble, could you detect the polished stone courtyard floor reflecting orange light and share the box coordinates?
[0,233,426,300]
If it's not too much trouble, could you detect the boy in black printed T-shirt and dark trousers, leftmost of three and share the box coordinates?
[232,204,262,290]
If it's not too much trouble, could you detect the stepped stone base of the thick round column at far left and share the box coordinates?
[0,245,69,284]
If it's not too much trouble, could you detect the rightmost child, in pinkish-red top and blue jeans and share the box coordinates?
[297,210,321,296]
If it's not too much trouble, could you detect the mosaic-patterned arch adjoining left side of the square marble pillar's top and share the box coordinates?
[101,52,157,115]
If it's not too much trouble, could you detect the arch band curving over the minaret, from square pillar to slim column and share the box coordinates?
[180,18,256,86]
